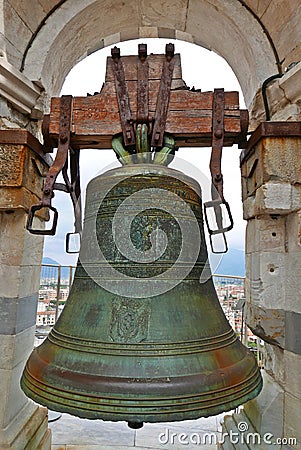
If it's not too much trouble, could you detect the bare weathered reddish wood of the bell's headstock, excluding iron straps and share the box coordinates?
[49,55,245,148]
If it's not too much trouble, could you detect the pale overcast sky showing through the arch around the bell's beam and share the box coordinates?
[44,39,245,265]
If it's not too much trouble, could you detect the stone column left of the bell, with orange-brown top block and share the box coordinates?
[0,130,51,450]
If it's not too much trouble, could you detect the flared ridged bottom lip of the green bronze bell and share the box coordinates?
[21,358,263,423]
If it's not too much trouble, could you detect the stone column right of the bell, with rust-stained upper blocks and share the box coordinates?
[218,122,301,449]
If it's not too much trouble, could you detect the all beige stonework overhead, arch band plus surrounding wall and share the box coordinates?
[0,0,301,112]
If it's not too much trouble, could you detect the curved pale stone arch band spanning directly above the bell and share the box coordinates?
[23,0,277,107]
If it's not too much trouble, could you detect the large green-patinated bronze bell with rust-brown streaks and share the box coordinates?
[21,163,262,427]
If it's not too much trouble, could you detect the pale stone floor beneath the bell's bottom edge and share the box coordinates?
[49,414,223,450]
